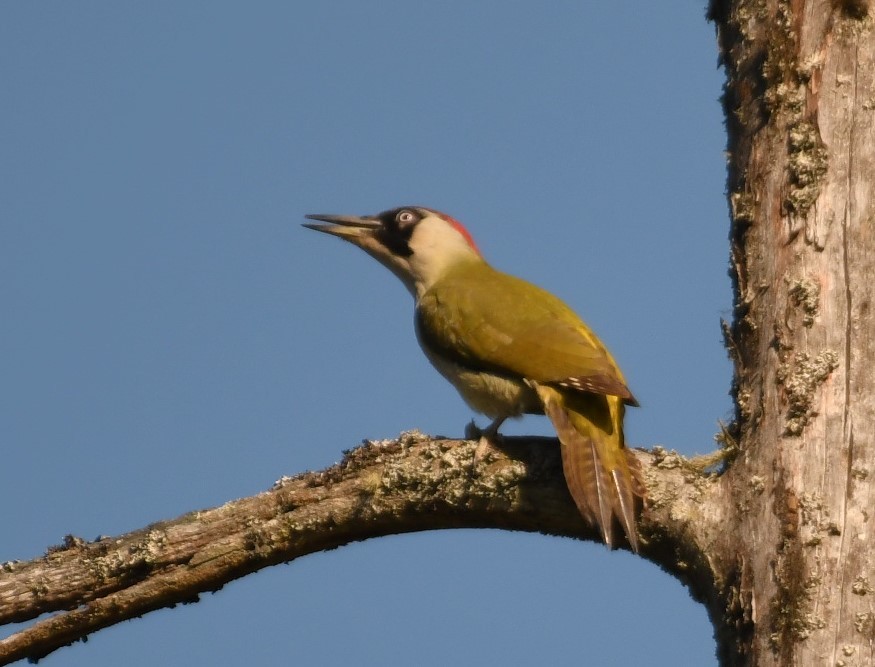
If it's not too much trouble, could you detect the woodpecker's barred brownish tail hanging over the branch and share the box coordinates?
[537,386,644,552]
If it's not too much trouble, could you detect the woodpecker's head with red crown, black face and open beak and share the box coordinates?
[304,206,483,297]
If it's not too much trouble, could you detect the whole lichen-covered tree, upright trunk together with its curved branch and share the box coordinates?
[0,0,875,666]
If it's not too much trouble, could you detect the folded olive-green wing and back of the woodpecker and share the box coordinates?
[416,264,637,405]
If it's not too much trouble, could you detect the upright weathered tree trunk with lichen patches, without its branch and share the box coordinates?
[711,0,875,665]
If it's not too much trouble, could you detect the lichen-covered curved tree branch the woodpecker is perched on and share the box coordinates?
[0,432,721,665]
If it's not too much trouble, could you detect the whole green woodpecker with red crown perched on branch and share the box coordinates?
[304,206,644,552]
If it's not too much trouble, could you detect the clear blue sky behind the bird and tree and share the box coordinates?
[0,0,731,667]
